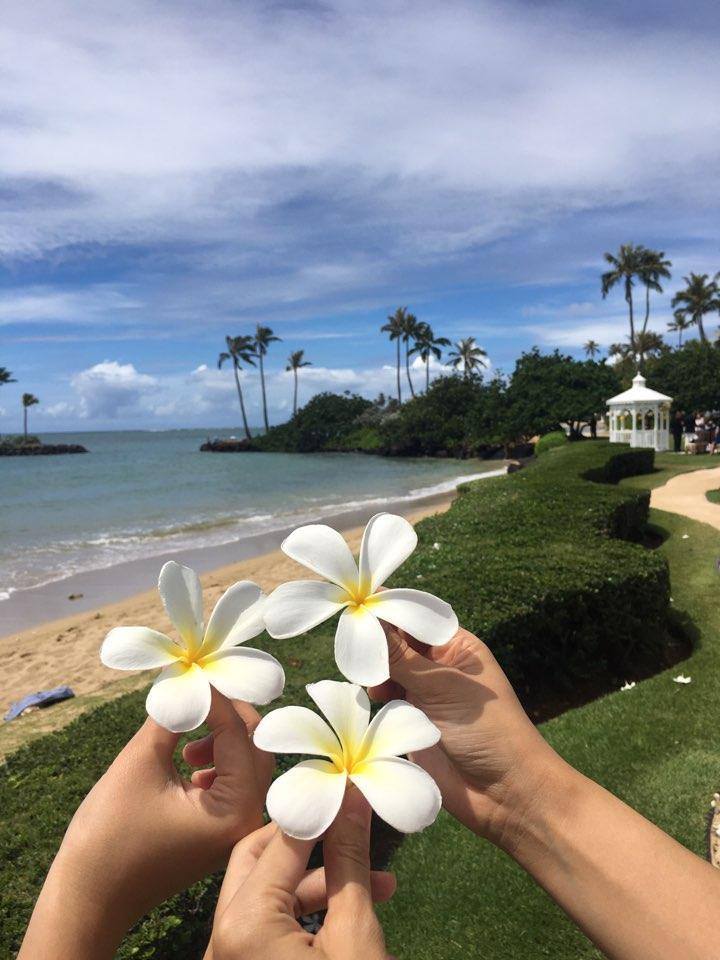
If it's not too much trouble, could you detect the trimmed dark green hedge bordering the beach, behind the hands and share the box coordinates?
[0,441,669,960]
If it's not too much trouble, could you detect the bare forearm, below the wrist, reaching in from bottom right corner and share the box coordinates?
[499,761,720,960]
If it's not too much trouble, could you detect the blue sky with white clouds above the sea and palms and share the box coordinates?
[0,0,720,432]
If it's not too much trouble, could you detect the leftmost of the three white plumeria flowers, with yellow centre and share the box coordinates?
[100,560,285,733]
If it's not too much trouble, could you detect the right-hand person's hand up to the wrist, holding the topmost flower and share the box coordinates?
[368,624,563,845]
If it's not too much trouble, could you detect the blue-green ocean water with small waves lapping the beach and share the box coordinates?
[0,430,498,600]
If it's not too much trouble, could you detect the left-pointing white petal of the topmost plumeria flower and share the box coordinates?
[263,580,350,640]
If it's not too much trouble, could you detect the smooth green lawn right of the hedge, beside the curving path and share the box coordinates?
[382,506,720,960]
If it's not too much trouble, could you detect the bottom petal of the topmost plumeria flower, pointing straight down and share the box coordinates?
[335,607,390,687]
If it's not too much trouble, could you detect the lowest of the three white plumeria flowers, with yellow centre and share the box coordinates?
[253,680,442,840]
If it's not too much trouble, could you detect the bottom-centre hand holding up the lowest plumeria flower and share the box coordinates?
[210,787,395,960]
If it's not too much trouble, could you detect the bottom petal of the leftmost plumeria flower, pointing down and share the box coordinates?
[145,662,212,733]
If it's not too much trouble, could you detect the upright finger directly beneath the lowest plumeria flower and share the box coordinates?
[323,784,372,911]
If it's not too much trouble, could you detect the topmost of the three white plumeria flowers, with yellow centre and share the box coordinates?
[265,513,458,686]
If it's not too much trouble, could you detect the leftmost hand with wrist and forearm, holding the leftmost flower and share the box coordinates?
[19,691,274,960]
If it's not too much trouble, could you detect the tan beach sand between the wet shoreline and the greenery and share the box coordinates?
[0,493,455,757]
